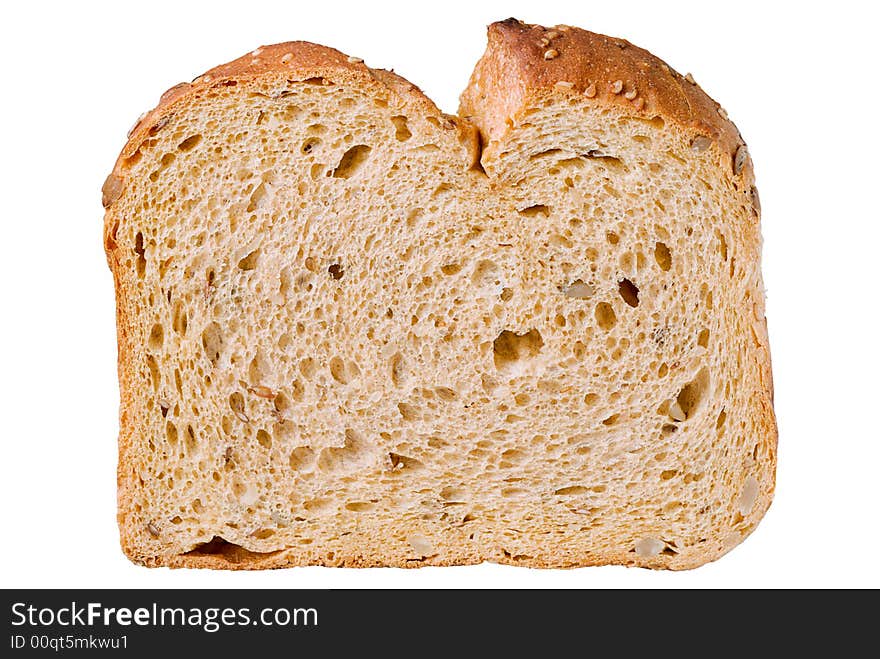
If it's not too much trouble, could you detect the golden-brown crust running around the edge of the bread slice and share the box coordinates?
[103,19,777,570]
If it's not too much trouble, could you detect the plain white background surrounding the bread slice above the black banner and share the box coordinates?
[0,0,880,588]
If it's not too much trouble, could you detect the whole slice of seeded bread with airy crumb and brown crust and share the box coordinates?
[103,20,776,569]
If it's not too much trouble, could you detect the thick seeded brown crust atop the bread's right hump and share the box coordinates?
[459,18,751,168]
